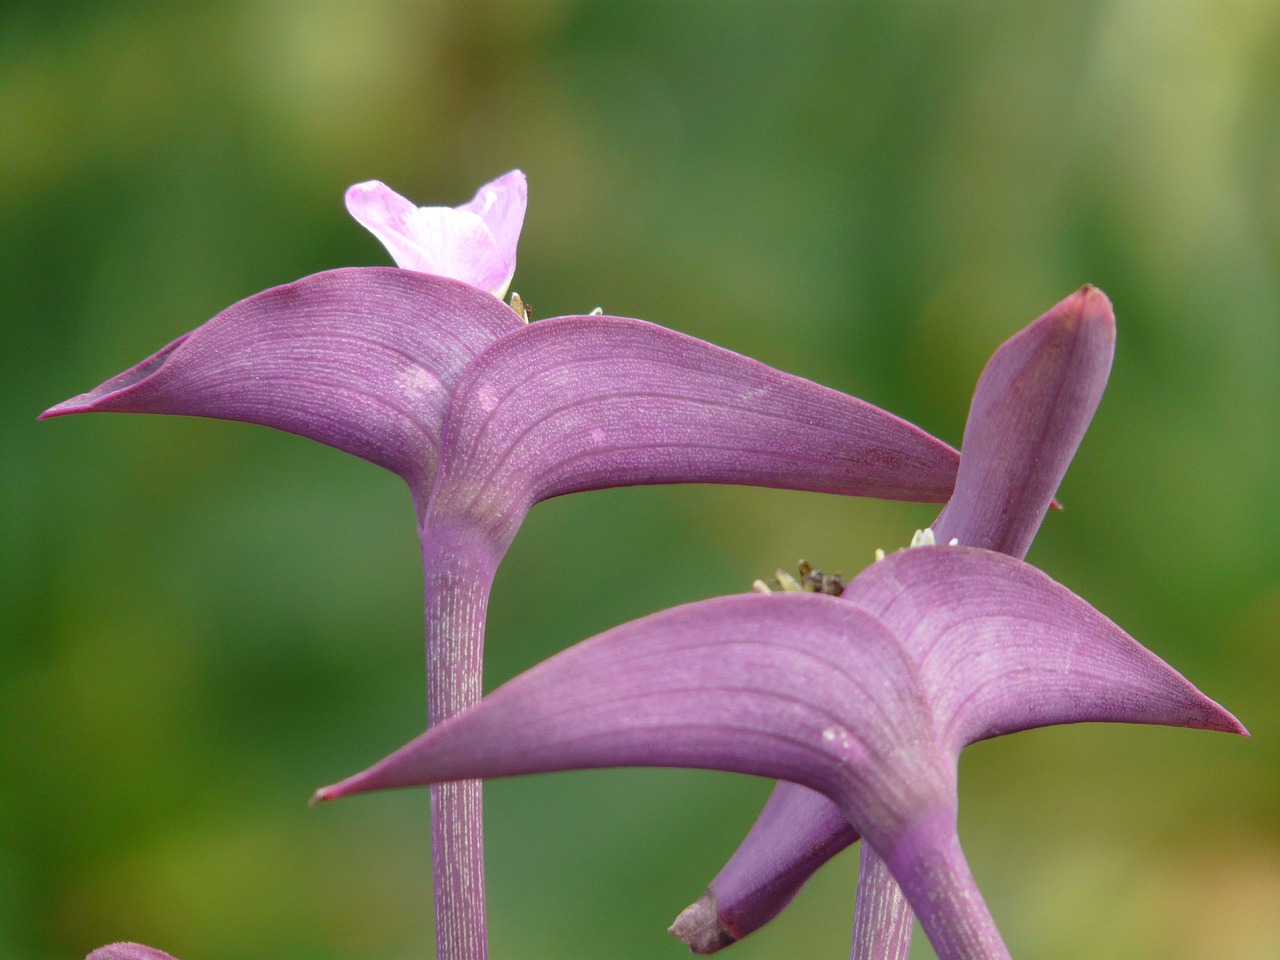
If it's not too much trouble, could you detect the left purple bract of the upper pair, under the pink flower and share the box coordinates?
[41,268,524,499]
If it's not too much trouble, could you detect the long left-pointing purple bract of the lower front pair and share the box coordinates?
[309,594,950,822]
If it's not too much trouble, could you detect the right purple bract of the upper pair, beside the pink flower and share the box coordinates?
[429,316,956,548]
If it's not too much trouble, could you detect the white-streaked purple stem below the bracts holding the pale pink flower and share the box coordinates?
[421,525,499,960]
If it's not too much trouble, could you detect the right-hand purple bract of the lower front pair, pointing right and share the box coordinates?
[844,547,1243,751]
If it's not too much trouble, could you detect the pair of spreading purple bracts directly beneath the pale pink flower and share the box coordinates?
[41,285,957,535]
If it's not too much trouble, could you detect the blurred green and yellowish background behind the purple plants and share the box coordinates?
[0,0,1280,960]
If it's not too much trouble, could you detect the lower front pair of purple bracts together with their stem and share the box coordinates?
[309,547,1244,960]
